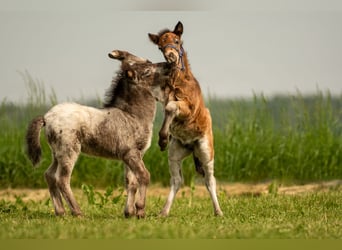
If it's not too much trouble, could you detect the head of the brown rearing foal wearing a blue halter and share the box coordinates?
[148,22,184,68]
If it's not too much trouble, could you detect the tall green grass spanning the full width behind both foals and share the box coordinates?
[0,72,342,187]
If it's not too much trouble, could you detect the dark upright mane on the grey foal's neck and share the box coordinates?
[103,70,127,108]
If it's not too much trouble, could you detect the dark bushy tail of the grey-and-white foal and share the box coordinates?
[26,116,45,166]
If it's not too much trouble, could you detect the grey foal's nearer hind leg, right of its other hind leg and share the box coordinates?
[57,148,82,216]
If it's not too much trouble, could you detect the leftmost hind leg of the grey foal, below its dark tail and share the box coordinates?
[44,156,65,215]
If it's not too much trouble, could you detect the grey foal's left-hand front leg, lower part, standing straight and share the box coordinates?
[124,165,138,218]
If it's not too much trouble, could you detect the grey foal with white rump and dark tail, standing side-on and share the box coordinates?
[26,50,170,218]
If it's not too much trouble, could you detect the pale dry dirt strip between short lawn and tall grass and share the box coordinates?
[0,180,342,202]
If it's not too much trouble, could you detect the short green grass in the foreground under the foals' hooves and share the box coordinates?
[0,188,342,239]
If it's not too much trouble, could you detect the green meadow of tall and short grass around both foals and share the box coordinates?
[0,72,342,239]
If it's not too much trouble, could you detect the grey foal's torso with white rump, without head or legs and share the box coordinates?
[44,100,151,159]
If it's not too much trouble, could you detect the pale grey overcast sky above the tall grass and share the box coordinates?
[0,0,342,102]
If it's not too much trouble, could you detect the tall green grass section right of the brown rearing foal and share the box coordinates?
[215,92,342,182]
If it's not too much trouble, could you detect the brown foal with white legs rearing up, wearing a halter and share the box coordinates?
[148,22,223,216]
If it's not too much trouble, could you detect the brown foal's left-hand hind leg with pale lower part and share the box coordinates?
[160,138,191,216]
